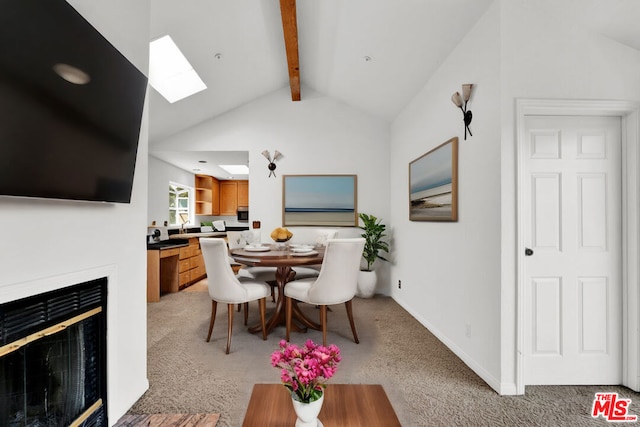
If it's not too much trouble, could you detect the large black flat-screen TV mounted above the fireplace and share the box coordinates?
[0,0,147,203]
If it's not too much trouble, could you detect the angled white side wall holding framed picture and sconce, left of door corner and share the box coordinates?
[391,4,500,388]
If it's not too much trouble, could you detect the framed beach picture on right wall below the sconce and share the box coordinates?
[409,137,458,221]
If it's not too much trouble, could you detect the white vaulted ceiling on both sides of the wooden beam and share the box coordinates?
[149,0,640,176]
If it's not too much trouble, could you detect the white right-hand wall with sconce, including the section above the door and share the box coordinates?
[391,0,640,394]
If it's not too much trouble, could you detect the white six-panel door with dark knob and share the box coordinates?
[520,116,622,385]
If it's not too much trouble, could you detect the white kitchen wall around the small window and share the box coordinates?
[147,156,199,225]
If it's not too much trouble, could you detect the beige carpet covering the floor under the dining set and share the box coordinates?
[130,288,640,427]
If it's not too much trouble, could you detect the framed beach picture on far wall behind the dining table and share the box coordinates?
[282,175,358,227]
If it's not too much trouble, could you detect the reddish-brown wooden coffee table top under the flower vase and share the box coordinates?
[242,384,400,427]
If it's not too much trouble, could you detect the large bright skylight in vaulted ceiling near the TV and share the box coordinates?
[149,35,207,104]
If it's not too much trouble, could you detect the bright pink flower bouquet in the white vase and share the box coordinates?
[271,340,340,403]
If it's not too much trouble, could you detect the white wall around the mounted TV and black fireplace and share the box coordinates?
[0,0,149,424]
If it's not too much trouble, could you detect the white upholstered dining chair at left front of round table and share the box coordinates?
[200,238,271,354]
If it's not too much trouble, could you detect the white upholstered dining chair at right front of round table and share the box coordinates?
[284,237,365,345]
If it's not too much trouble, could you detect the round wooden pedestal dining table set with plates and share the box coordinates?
[230,244,325,333]
